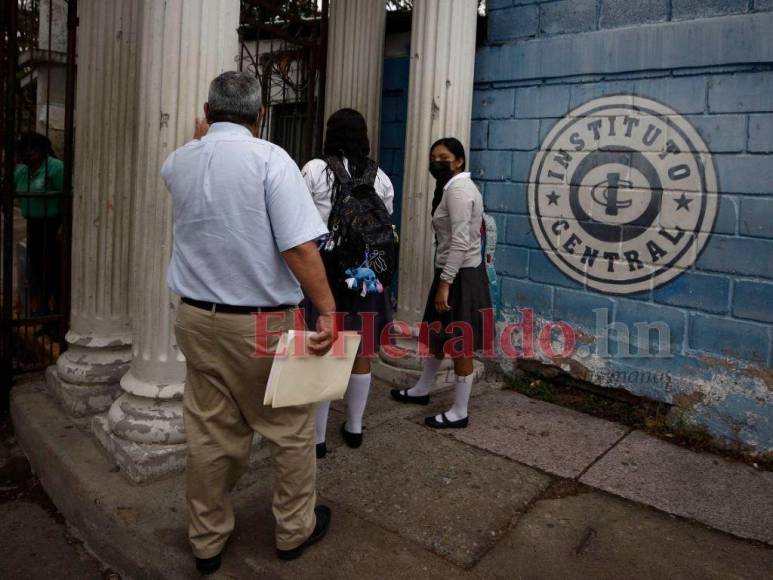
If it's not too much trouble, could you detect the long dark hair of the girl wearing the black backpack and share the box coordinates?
[322,109,370,177]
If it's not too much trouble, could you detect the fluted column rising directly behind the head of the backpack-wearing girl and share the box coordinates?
[325,0,386,159]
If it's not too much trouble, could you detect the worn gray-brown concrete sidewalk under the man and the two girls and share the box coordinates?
[7,374,773,579]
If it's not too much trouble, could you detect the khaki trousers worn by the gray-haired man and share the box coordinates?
[175,304,317,558]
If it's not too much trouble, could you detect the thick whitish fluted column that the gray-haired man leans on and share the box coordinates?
[94,0,239,481]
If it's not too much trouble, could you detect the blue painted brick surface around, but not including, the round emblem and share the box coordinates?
[470,0,773,451]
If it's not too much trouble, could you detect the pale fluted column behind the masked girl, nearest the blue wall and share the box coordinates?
[373,0,482,387]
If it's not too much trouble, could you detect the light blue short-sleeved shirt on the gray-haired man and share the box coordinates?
[161,123,327,306]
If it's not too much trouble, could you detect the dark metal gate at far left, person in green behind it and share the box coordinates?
[0,0,77,406]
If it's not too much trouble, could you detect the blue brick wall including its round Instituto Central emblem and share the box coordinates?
[471,0,773,452]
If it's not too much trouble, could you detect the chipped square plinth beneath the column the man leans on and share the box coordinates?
[91,415,187,483]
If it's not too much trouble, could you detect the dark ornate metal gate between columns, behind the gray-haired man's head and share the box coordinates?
[239,0,328,165]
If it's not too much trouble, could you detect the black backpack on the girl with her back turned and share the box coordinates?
[322,156,397,289]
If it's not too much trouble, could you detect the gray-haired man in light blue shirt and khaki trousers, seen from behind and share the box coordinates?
[161,72,336,573]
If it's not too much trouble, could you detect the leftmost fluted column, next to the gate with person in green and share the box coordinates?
[46,0,139,416]
